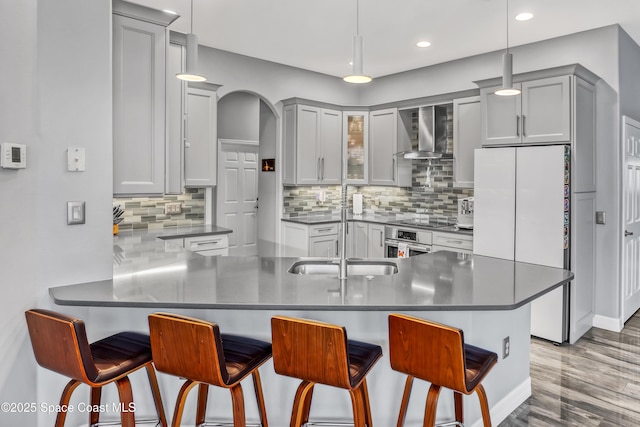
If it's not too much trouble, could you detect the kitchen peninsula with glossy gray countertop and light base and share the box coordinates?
[50,232,573,427]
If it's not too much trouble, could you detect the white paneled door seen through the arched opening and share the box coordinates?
[216,140,259,256]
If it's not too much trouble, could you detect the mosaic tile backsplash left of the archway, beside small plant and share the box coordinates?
[113,188,205,230]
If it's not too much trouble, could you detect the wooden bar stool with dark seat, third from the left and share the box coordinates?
[271,316,382,427]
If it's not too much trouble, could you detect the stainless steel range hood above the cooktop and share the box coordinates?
[402,105,453,159]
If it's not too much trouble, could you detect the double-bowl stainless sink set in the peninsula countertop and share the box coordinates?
[287,259,398,276]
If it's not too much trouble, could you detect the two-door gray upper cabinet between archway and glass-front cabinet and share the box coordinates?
[284,104,342,185]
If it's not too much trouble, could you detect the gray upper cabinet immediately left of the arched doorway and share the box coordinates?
[184,83,218,187]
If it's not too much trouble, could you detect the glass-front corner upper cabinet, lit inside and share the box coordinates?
[342,111,369,185]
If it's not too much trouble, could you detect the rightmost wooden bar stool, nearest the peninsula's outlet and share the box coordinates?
[389,314,498,427]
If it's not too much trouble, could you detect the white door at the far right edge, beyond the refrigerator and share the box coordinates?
[622,117,640,321]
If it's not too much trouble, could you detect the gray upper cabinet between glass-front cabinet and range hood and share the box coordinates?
[369,108,411,187]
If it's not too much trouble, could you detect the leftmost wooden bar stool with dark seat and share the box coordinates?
[25,309,167,427]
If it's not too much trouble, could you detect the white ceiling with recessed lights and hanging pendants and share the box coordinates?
[128,0,640,77]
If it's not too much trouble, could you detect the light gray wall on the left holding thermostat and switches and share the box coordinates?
[0,0,112,426]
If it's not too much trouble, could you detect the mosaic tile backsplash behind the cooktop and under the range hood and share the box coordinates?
[284,160,473,221]
